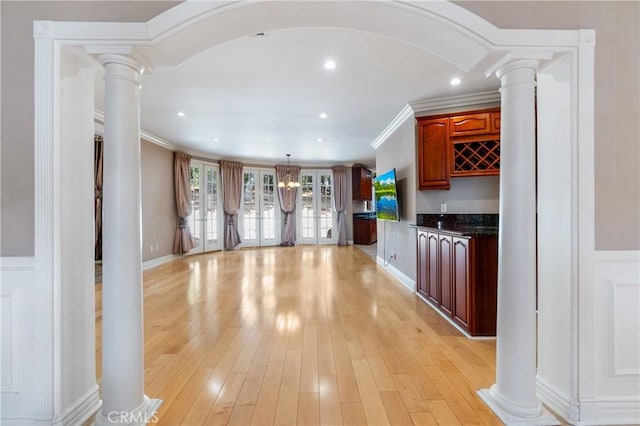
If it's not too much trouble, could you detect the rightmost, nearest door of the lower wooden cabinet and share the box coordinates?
[453,237,470,328]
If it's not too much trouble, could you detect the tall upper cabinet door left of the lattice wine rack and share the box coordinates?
[418,118,451,189]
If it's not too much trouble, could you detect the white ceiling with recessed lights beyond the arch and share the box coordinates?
[96,28,499,166]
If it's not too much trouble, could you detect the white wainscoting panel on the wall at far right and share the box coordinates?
[580,251,640,424]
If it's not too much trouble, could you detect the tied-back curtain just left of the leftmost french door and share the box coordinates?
[173,152,196,254]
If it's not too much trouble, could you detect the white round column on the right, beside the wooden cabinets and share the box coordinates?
[478,59,560,425]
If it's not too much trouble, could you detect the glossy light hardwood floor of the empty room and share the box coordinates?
[96,246,501,426]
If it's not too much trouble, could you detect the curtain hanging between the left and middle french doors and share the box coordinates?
[220,161,243,250]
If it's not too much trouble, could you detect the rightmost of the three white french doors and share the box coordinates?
[297,170,338,244]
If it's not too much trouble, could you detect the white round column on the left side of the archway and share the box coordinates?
[97,54,160,424]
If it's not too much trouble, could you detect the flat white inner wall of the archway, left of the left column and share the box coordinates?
[54,50,98,420]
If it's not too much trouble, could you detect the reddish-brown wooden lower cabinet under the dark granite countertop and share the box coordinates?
[417,228,498,336]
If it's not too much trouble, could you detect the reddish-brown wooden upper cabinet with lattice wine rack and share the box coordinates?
[417,108,500,190]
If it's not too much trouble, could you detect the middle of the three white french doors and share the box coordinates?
[239,168,280,247]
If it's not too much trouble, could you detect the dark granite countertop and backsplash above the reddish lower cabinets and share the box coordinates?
[412,214,498,237]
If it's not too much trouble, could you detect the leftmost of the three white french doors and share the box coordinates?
[189,161,223,254]
